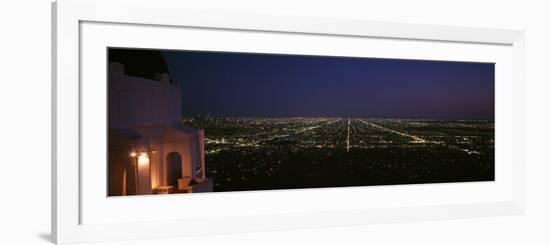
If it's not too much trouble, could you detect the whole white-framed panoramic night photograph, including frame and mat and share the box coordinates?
[52,0,524,243]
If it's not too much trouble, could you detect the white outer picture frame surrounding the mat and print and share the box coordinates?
[52,0,524,244]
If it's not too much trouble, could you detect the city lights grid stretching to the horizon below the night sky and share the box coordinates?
[185,117,494,191]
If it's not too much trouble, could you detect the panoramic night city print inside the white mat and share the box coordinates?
[107,48,495,196]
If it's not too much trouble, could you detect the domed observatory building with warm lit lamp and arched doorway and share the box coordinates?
[108,49,212,196]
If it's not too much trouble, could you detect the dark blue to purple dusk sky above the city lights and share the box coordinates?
[163,51,495,120]
